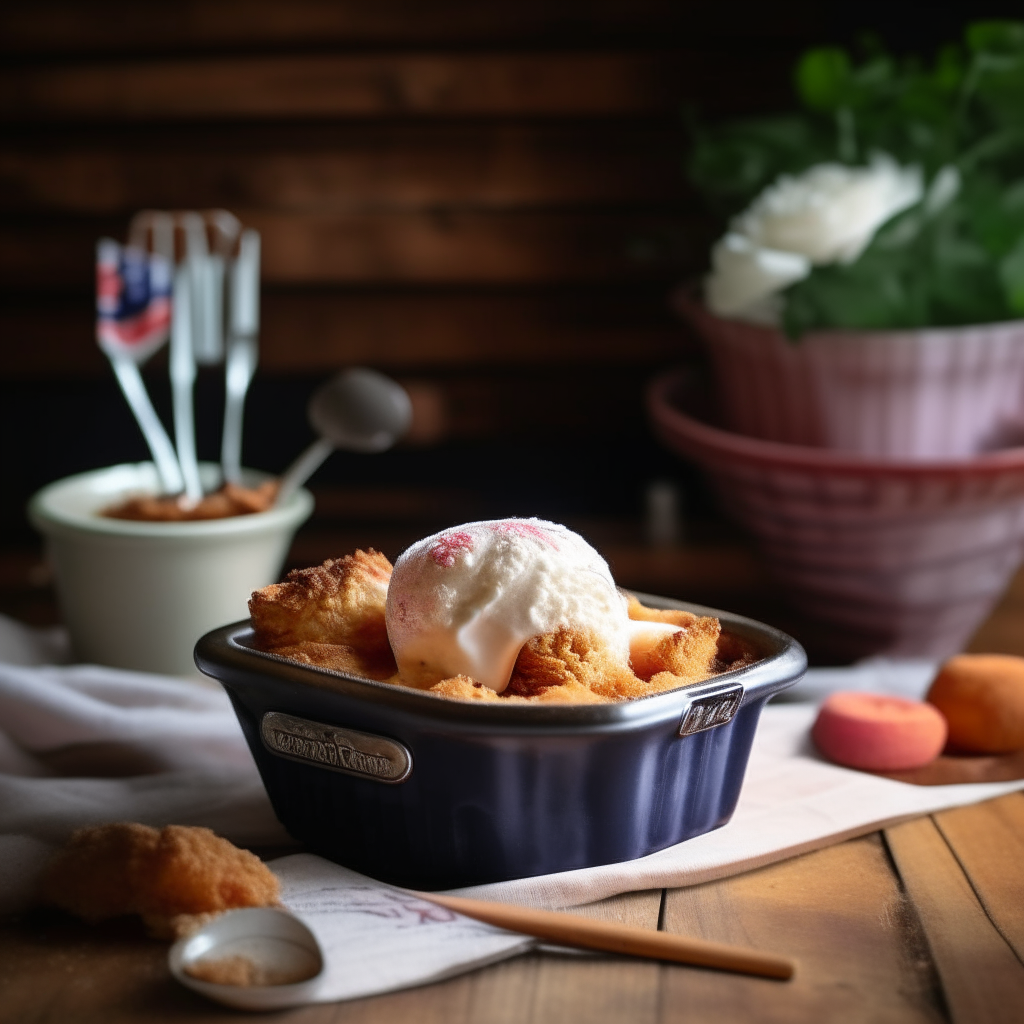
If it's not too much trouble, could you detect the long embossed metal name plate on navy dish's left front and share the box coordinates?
[260,711,413,782]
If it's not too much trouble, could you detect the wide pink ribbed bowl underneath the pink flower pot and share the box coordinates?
[648,371,1024,657]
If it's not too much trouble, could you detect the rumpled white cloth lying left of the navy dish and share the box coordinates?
[0,615,292,913]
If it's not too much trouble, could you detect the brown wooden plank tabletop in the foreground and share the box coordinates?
[0,794,1024,1024]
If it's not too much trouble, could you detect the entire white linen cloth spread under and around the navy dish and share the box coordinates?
[0,616,1024,998]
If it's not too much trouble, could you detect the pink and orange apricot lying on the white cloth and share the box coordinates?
[811,691,946,771]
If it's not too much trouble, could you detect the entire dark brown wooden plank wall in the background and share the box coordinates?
[0,0,998,659]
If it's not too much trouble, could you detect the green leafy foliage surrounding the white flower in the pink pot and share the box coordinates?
[689,22,1024,337]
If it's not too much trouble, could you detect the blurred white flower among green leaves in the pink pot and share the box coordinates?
[706,154,924,322]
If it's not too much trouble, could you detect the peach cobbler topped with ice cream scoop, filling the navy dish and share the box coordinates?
[249,519,757,703]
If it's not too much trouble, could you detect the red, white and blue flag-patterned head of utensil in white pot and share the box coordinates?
[96,239,171,362]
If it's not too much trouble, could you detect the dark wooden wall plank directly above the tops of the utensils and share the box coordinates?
[0,120,684,212]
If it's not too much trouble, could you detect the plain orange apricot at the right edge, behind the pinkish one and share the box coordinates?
[927,654,1024,754]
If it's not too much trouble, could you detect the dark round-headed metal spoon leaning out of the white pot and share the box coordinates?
[275,367,413,505]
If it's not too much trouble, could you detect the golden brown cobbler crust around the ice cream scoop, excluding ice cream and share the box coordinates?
[249,550,758,703]
